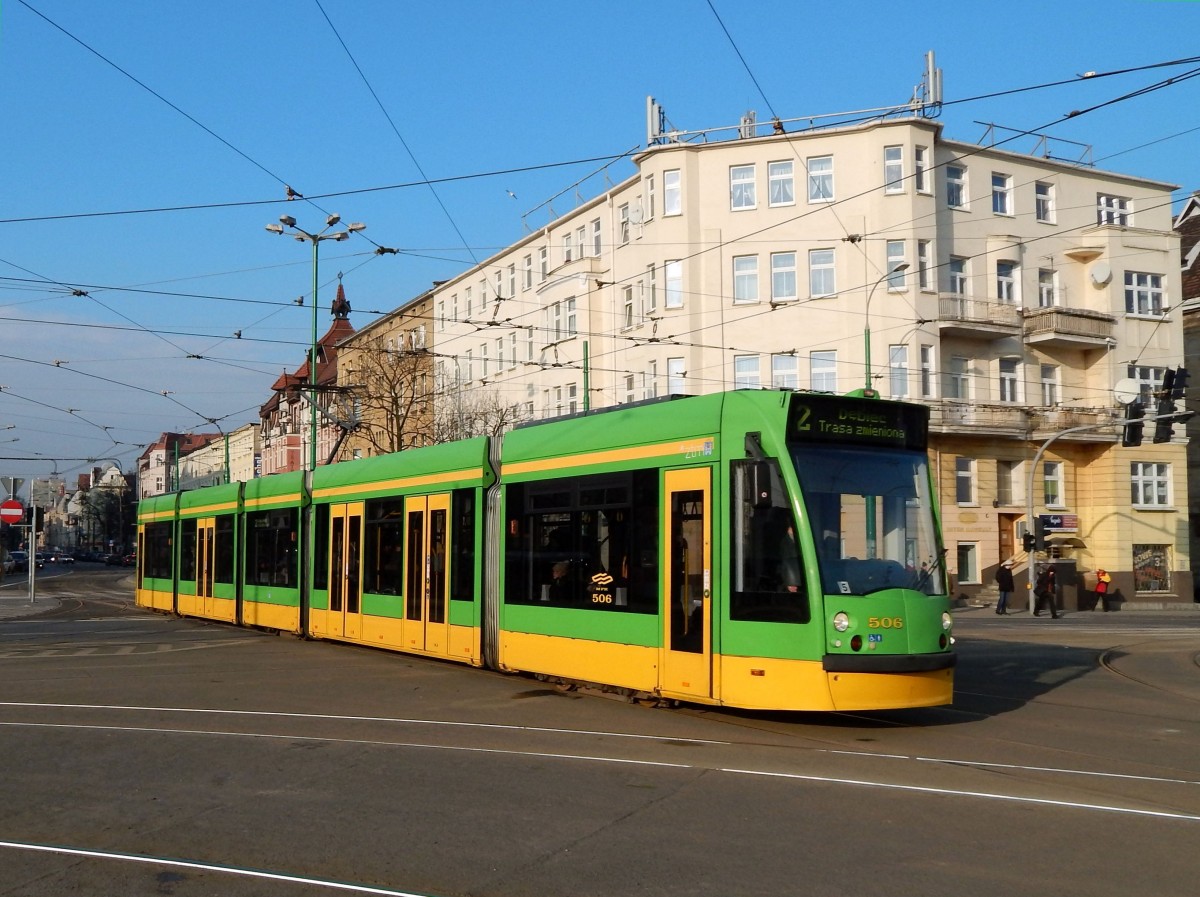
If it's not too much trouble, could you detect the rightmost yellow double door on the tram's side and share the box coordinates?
[404,493,450,655]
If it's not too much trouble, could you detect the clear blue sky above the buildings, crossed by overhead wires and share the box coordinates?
[0,0,1200,491]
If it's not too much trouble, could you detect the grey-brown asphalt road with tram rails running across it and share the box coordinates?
[0,565,1200,897]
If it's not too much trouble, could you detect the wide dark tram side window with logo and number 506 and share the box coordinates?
[505,470,659,614]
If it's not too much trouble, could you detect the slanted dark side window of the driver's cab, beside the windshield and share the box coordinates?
[730,460,810,622]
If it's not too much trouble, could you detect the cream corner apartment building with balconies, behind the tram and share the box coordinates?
[415,115,1193,607]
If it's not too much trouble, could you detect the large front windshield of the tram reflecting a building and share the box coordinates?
[791,445,946,595]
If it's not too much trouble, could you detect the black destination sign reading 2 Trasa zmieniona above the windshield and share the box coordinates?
[787,393,929,451]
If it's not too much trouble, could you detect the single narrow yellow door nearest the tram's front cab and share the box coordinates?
[661,468,713,698]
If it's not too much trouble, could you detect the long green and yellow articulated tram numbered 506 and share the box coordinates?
[137,391,955,710]
